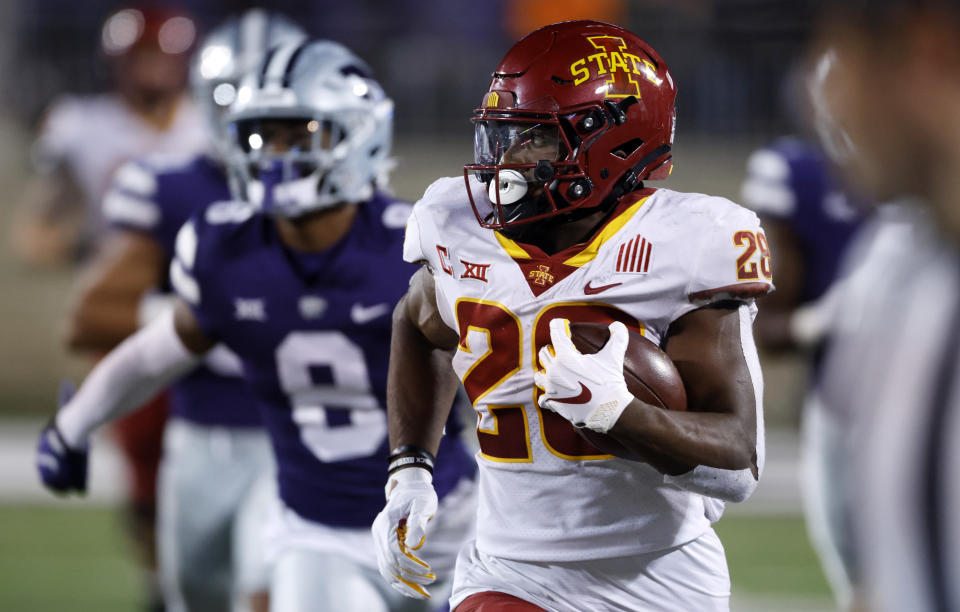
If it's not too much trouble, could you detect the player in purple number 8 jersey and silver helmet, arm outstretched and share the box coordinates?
[38,41,476,612]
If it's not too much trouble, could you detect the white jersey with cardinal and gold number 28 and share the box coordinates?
[404,178,772,562]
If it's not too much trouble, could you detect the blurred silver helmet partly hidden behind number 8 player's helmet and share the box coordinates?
[190,8,307,156]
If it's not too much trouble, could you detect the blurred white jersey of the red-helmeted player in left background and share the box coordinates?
[35,94,209,227]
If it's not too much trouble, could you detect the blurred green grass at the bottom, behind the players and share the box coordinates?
[0,506,829,612]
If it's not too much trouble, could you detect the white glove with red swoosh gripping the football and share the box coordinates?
[534,319,634,433]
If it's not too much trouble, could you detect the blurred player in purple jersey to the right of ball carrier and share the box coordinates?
[742,137,866,607]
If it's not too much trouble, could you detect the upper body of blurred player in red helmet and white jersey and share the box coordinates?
[11,6,207,265]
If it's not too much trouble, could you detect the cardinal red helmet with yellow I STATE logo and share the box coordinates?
[464,21,676,230]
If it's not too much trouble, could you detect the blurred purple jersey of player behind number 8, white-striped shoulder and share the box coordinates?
[103,155,260,427]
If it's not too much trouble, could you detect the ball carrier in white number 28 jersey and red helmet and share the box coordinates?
[373,21,773,612]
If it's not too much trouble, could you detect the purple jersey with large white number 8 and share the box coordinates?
[171,194,475,527]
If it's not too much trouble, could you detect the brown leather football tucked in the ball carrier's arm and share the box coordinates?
[570,323,687,467]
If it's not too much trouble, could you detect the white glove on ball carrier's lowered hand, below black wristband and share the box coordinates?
[371,467,437,599]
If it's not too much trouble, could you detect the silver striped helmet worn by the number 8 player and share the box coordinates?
[226,41,393,218]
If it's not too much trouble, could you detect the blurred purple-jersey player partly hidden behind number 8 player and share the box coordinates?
[70,9,305,612]
